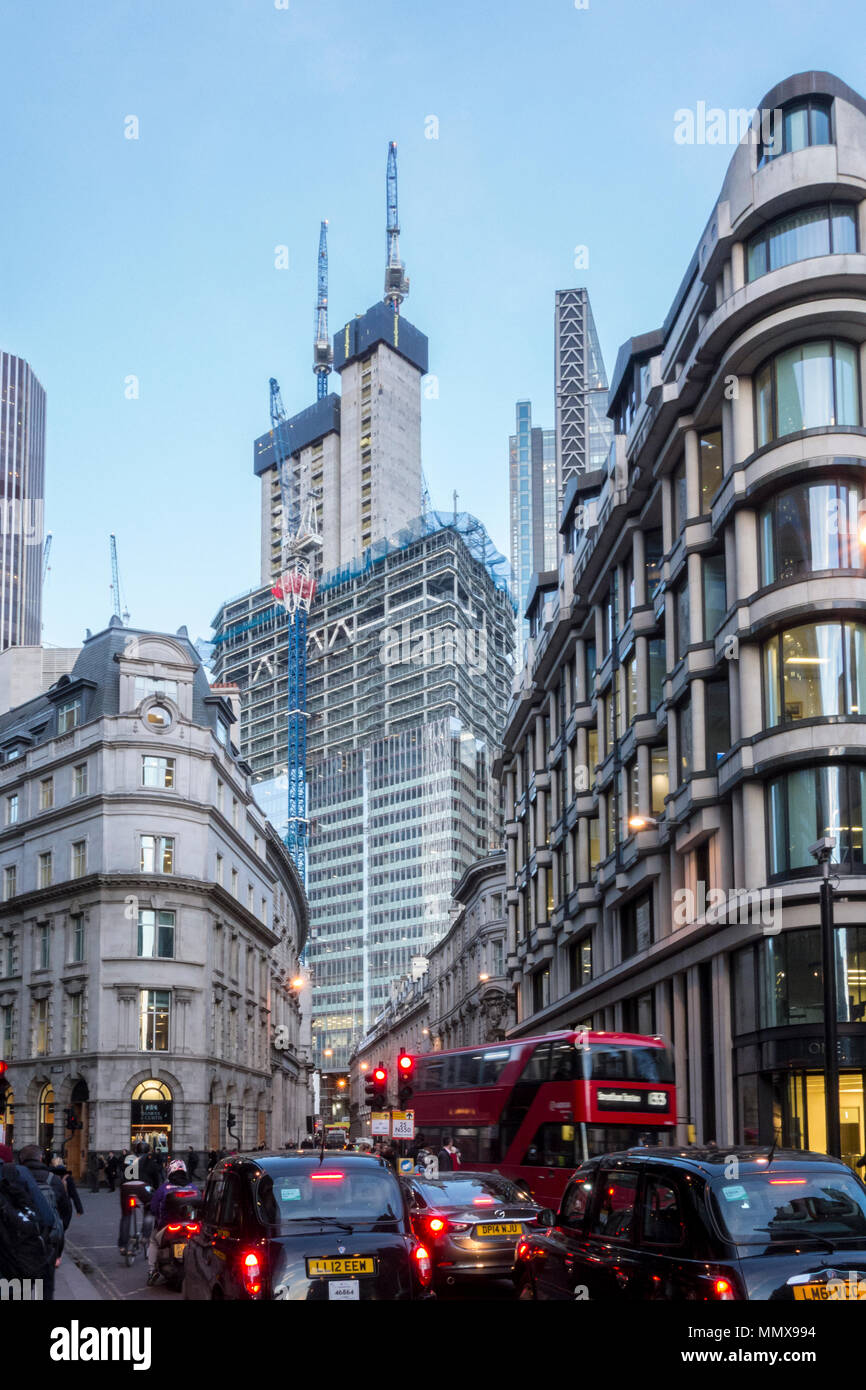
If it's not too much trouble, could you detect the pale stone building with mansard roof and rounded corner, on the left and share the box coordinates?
[0,619,310,1169]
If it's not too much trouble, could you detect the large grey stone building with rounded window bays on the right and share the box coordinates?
[500,72,866,1162]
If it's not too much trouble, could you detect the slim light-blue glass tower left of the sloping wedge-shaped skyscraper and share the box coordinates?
[509,400,559,645]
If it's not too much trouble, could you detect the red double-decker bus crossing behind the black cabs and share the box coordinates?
[411,1031,677,1205]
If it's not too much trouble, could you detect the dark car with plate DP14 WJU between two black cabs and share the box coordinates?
[403,1170,541,1284]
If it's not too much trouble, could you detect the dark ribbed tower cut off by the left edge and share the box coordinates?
[0,352,44,651]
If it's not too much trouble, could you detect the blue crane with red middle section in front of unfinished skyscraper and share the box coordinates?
[270,377,321,885]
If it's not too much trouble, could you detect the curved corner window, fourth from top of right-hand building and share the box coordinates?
[760,482,866,584]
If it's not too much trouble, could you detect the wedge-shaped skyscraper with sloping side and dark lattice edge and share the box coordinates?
[555,289,613,507]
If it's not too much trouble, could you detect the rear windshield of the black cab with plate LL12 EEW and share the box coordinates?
[256,1163,403,1229]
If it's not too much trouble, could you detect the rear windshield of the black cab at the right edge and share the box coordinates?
[710,1172,866,1245]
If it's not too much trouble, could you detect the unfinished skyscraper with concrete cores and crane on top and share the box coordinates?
[214,147,514,1070]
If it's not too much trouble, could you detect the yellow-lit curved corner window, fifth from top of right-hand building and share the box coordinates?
[763,623,866,727]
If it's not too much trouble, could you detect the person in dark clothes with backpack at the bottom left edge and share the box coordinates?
[0,1144,63,1301]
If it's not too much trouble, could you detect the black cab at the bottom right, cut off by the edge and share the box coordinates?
[517,1148,866,1302]
